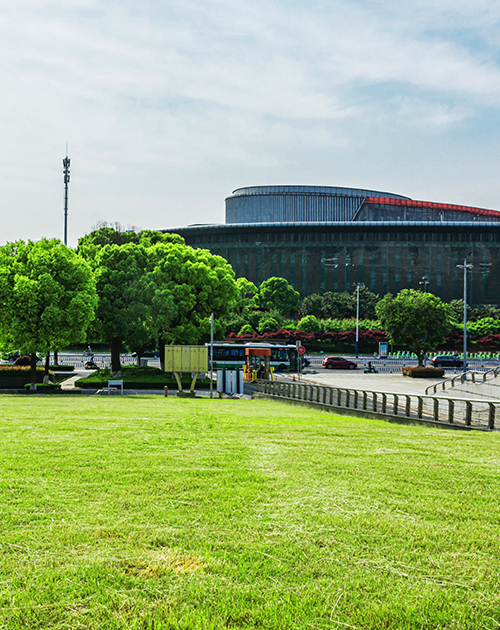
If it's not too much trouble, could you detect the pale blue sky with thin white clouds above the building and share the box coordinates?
[0,0,500,247]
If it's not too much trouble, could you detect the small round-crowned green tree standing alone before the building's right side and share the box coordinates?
[377,289,450,366]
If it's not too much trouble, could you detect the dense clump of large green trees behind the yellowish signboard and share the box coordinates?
[79,228,238,372]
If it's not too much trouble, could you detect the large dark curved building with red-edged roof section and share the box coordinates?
[170,186,500,305]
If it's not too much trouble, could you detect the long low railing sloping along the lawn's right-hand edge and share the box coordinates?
[257,380,500,431]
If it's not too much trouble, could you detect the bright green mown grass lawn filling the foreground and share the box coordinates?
[0,396,500,630]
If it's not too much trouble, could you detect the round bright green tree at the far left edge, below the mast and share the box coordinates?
[0,239,96,388]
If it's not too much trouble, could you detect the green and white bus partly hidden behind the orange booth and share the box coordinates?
[206,342,299,372]
